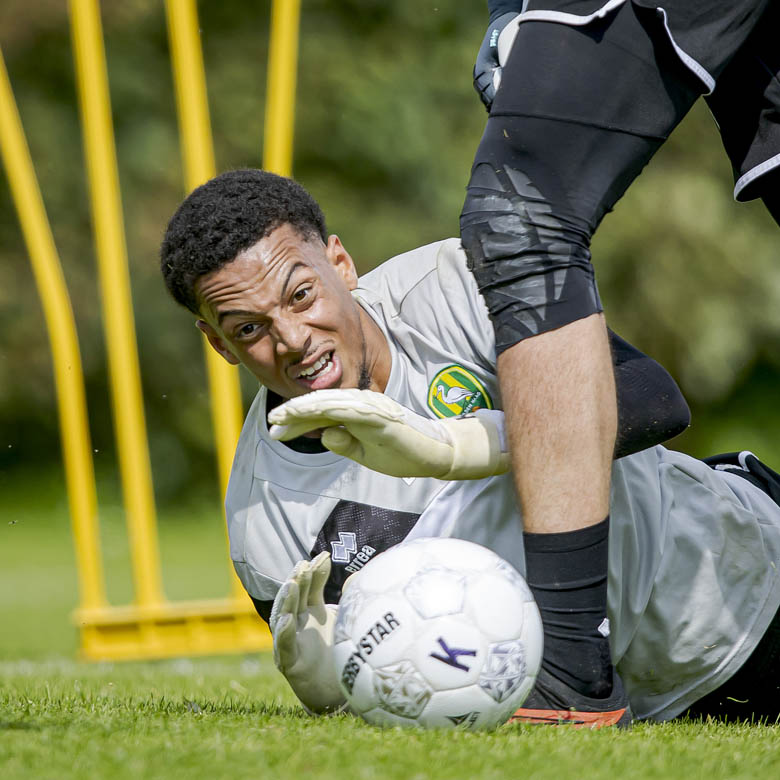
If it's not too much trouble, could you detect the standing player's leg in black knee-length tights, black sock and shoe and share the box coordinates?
[461,3,701,724]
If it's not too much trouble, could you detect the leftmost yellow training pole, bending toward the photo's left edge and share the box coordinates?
[0,45,106,609]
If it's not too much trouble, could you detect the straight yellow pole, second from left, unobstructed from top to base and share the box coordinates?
[70,0,163,607]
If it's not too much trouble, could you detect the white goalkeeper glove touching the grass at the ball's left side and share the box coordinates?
[269,552,345,714]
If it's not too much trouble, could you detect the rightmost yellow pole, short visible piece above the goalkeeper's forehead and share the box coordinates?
[263,0,301,176]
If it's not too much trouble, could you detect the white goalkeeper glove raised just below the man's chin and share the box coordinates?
[268,390,509,480]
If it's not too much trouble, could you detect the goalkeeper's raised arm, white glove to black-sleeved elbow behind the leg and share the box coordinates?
[268,331,690,480]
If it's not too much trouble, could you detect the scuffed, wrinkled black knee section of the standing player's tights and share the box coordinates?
[460,163,601,353]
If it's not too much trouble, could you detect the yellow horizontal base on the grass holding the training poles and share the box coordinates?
[73,598,272,661]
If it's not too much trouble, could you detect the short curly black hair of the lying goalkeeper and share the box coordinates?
[160,168,328,314]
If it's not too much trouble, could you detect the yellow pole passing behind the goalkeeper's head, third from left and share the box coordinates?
[165,0,246,598]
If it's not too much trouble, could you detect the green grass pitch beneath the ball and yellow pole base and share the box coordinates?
[0,466,780,780]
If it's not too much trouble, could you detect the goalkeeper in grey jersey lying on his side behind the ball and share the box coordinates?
[161,170,780,726]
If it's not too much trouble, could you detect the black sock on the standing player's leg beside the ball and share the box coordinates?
[523,516,612,698]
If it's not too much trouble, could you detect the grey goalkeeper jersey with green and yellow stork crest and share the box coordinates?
[227,239,780,719]
